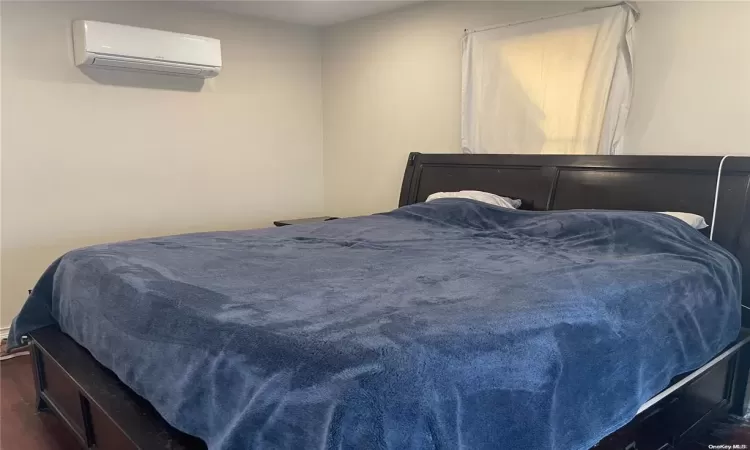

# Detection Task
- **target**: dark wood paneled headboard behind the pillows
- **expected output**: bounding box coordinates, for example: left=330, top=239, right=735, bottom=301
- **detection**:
left=399, top=153, right=750, bottom=327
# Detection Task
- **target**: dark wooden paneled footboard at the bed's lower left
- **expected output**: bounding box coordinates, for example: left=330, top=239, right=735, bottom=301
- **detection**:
left=31, top=327, right=206, bottom=450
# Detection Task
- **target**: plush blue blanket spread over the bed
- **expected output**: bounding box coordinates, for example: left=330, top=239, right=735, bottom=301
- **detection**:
left=11, top=199, right=740, bottom=450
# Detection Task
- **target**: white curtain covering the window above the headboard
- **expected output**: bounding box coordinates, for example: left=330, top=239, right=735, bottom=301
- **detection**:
left=461, top=3, right=637, bottom=154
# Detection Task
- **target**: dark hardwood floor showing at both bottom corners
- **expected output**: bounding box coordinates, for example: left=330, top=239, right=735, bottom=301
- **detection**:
left=0, top=356, right=750, bottom=450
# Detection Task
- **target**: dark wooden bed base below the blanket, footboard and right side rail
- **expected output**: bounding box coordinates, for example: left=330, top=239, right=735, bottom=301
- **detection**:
left=31, top=327, right=750, bottom=450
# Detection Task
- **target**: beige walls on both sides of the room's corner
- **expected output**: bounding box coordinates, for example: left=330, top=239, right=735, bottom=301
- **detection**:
left=0, top=1, right=750, bottom=326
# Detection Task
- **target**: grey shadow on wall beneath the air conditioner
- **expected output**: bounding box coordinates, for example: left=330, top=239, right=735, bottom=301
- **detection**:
left=80, top=67, right=204, bottom=92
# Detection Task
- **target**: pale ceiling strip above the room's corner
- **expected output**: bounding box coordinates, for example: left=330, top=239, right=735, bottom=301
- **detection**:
left=207, top=0, right=423, bottom=26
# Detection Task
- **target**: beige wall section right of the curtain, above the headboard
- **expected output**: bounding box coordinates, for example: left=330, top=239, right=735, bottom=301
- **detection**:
left=626, top=2, right=750, bottom=155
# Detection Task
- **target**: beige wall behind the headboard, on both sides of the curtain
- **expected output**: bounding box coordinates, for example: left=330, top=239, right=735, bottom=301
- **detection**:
left=323, top=2, right=750, bottom=215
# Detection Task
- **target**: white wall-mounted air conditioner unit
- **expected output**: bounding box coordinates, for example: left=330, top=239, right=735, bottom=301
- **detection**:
left=73, top=20, right=221, bottom=78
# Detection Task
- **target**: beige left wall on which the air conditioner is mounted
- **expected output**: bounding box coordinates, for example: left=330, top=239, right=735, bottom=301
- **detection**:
left=0, top=2, right=323, bottom=326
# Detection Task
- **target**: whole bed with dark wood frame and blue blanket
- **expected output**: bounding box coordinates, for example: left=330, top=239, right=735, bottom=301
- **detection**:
left=10, top=154, right=750, bottom=449
